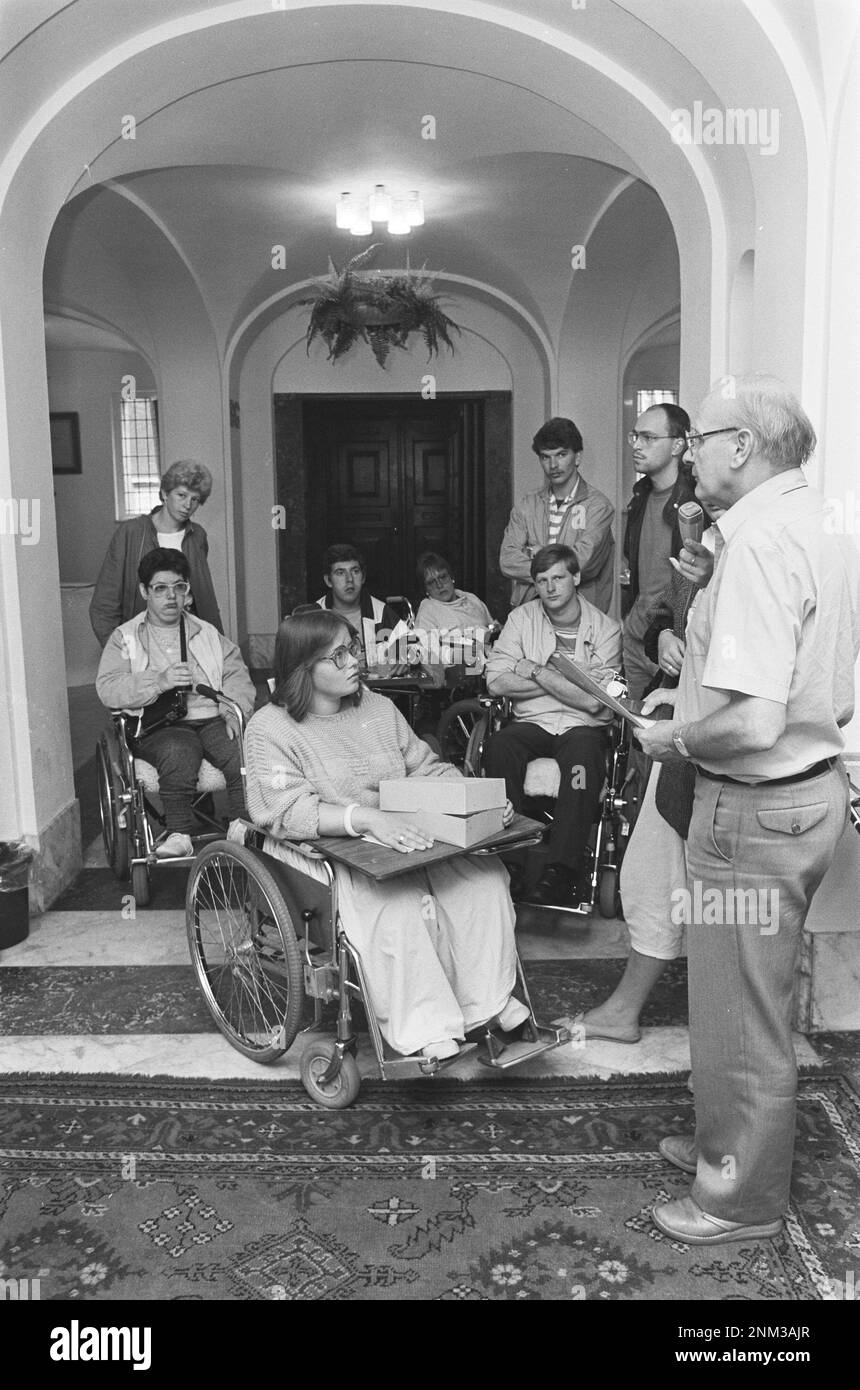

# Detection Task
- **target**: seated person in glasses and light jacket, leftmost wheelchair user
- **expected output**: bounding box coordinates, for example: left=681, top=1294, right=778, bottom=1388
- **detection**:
left=96, top=549, right=256, bottom=858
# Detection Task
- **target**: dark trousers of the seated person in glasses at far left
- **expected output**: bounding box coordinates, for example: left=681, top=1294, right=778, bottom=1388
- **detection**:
left=135, top=714, right=247, bottom=835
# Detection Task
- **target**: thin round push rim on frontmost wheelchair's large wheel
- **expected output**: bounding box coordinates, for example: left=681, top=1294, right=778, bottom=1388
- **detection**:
left=193, top=855, right=293, bottom=1054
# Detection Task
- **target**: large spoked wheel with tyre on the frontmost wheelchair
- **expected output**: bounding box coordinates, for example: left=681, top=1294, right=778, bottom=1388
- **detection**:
left=185, top=840, right=304, bottom=1062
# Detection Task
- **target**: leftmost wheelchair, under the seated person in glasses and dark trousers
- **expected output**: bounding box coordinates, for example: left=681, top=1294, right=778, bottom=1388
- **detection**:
left=96, top=702, right=238, bottom=908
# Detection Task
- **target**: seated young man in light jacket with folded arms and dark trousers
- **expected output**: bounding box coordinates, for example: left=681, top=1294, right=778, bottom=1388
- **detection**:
left=483, top=545, right=621, bottom=906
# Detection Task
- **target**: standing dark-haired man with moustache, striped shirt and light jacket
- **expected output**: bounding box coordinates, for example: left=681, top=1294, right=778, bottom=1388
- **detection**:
left=499, top=416, right=615, bottom=613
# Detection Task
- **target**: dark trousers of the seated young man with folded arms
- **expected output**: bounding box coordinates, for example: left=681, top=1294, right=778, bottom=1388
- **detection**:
left=483, top=720, right=606, bottom=869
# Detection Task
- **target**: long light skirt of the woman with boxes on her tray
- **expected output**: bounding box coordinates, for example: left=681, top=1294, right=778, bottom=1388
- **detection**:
left=265, top=837, right=517, bottom=1054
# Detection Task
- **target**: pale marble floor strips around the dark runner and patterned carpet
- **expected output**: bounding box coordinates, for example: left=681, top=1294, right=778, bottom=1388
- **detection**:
left=0, top=822, right=839, bottom=1084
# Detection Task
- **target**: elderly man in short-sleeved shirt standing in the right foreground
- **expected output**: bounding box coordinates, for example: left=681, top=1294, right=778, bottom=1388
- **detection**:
left=636, top=377, right=860, bottom=1245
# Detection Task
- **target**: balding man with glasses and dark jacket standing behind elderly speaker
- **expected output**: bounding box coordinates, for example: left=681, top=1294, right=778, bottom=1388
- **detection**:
left=621, top=403, right=695, bottom=699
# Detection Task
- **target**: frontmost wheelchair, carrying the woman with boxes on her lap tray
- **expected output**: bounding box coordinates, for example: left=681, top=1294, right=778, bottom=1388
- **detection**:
left=186, top=683, right=572, bottom=1109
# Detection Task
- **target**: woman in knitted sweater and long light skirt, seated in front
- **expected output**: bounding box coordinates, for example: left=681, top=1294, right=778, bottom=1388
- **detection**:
left=245, top=612, right=528, bottom=1059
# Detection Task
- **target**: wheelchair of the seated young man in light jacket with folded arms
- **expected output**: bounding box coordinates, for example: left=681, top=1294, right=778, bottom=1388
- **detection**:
left=438, top=695, right=638, bottom=917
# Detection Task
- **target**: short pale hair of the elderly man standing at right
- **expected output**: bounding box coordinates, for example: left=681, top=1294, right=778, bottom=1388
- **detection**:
left=706, top=373, right=817, bottom=468
